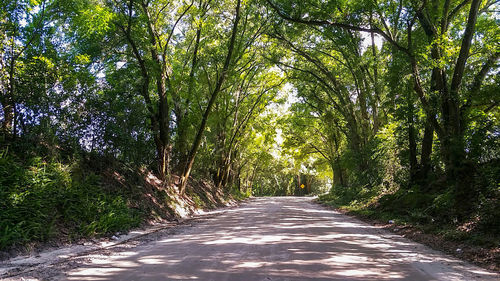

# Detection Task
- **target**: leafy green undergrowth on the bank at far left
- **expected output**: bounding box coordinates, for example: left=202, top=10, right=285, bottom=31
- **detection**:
left=0, top=151, right=143, bottom=250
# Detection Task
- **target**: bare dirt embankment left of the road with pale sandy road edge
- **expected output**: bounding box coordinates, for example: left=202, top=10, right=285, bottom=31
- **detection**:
left=0, top=168, right=242, bottom=280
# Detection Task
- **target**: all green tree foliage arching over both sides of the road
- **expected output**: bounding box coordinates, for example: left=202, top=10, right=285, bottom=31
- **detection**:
left=0, top=0, right=500, bottom=247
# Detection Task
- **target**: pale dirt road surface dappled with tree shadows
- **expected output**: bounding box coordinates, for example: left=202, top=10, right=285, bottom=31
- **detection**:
left=61, top=197, right=496, bottom=280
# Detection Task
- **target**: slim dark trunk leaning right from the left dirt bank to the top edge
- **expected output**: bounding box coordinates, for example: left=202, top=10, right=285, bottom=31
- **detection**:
left=180, top=0, right=241, bottom=194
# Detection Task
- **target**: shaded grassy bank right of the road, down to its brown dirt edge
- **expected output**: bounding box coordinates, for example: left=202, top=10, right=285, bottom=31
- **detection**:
left=318, top=186, right=500, bottom=271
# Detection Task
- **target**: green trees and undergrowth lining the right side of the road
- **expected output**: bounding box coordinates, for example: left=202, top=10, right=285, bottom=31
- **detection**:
left=267, top=0, right=500, bottom=245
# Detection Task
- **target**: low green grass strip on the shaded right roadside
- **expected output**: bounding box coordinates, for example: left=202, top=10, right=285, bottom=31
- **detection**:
left=318, top=190, right=500, bottom=248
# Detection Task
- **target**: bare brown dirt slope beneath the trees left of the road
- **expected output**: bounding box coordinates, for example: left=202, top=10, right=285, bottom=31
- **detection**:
left=0, top=159, right=242, bottom=262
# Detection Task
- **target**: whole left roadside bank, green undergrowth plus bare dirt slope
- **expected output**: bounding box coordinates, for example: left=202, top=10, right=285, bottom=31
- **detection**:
left=0, top=144, right=246, bottom=254
